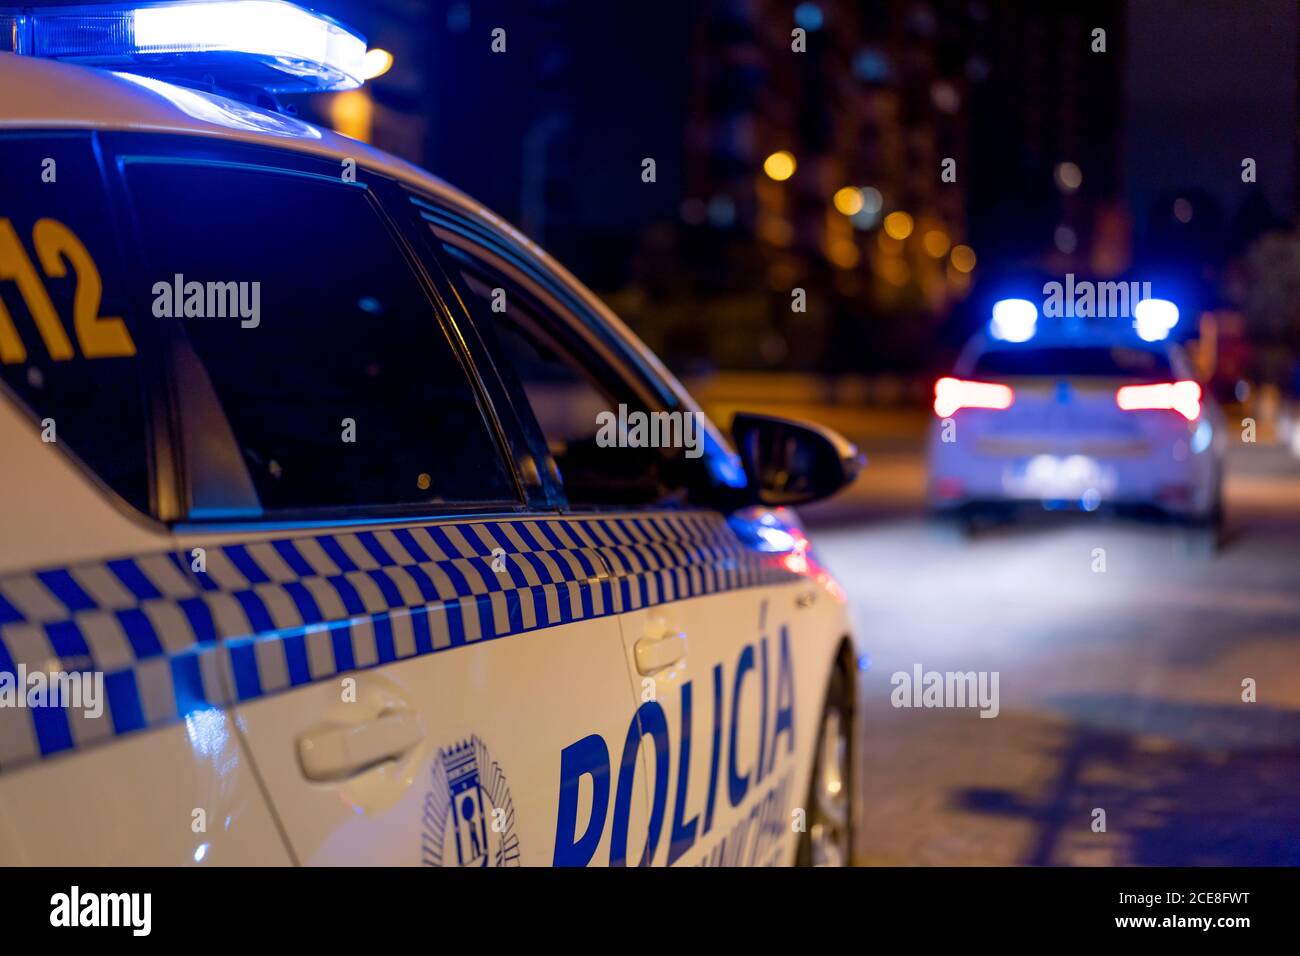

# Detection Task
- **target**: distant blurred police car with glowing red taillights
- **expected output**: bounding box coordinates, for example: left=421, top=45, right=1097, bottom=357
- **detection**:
left=928, top=298, right=1226, bottom=535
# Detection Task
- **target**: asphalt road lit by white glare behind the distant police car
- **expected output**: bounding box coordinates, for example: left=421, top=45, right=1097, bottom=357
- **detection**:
left=805, top=441, right=1300, bottom=865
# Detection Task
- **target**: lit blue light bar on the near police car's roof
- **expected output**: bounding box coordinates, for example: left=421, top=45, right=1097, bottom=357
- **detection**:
left=0, top=0, right=365, bottom=92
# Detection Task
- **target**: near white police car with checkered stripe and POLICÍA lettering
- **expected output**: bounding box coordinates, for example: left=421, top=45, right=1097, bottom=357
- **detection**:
left=0, top=1, right=861, bottom=866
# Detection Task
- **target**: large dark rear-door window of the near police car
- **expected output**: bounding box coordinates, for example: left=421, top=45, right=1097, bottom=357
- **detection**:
left=125, top=160, right=517, bottom=511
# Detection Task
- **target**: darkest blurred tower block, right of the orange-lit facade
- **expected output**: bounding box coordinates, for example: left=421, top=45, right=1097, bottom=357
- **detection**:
left=966, top=0, right=1132, bottom=278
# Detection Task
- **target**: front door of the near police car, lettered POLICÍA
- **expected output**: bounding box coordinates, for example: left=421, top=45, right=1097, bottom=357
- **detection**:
left=421, top=206, right=832, bottom=865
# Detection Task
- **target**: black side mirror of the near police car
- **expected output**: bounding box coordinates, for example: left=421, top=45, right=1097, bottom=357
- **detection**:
left=732, top=412, right=866, bottom=506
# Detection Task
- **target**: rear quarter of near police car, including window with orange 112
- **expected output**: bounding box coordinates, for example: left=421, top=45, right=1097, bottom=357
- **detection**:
left=0, top=130, right=287, bottom=866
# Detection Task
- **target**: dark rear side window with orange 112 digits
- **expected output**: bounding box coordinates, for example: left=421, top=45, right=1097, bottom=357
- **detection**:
left=0, top=133, right=151, bottom=512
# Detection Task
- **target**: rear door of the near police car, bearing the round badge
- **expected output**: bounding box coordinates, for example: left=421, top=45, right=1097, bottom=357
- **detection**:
left=117, top=138, right=644, bottom=866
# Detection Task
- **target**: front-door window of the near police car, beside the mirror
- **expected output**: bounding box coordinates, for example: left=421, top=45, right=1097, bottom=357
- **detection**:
left=442, top=243, right=702, bottom=506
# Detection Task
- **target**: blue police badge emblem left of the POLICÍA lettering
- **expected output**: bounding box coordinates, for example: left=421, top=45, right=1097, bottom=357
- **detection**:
left=420, top=736, right=519, bottom=866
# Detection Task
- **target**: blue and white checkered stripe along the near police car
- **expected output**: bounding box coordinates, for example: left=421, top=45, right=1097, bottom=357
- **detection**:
left=0, top=511, right=792, bottom=771
